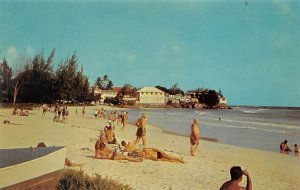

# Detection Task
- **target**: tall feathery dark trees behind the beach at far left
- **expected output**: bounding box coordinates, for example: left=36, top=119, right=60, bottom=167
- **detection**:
left=0, top=49, right=113, bottom=103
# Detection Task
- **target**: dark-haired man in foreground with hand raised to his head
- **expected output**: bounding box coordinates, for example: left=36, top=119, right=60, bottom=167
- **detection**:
left=220, top=166, right=252, bottom=190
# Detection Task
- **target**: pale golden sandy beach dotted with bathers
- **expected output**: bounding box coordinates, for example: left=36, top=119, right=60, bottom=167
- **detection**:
left=0, top=106, right=300, bottom=190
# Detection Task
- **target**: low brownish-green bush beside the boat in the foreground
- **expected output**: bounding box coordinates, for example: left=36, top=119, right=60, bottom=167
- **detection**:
left=57, top=169, right=132, bottom=190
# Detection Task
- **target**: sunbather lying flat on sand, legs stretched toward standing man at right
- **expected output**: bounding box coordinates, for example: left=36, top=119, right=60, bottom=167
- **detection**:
left=138, top=148, right=184, bottom=163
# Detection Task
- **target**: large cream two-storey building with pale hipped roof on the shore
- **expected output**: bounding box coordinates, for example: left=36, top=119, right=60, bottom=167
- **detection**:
left=137, top=87, right=165, bottom=105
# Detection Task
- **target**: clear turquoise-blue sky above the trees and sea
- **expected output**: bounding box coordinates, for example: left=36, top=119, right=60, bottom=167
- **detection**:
left=0, top=0, right=300, bottom=106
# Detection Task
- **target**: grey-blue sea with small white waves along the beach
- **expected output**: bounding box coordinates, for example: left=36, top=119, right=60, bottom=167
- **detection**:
left=123, top=107, right=300, bottom=152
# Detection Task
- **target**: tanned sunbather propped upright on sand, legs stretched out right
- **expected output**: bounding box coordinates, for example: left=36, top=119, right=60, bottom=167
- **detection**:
left=95, top=139, right=143, bottom=162
